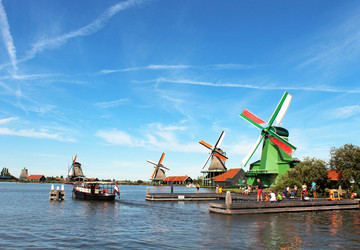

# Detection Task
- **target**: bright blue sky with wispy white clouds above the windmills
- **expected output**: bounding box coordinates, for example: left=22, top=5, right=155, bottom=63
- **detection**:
left=0, top=0, right=360, bottom=180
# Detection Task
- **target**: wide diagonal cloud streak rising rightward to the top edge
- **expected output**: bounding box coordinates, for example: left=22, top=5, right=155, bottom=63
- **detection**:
left=19, top=0, right=144, bottom=61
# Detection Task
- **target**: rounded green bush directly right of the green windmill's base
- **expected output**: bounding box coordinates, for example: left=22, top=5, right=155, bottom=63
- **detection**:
left=274, top=157, right=329, bottom=193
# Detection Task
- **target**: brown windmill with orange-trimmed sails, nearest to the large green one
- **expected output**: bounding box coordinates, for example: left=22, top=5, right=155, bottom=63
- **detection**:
left=199, top=131, right=228, bottom=186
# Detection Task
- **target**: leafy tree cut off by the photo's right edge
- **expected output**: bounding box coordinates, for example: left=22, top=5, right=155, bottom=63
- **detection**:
left=329, top=144, right=360, bottom=192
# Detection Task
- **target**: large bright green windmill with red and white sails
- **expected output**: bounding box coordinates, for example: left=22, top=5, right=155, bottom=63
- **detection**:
left=240, top=92, right=299, bottom=187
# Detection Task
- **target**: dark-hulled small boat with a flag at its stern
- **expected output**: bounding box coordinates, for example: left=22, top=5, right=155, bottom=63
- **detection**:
left=73, top=181, right=120, bottom=201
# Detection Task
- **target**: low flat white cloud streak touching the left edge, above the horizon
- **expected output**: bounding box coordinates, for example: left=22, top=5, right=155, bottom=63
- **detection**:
left=0, top=128, right=75, bottom=142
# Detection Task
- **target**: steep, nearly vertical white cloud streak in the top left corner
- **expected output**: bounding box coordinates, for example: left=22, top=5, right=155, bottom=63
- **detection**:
left=0, top=0, right=17, bottom=72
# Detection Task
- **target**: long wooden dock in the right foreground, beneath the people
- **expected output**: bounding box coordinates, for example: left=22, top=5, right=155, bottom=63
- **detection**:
left=209, top=199, right=359, bottom=215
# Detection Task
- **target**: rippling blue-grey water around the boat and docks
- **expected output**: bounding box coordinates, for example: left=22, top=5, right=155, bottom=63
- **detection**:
left=0, top=183, right=360, bottom=249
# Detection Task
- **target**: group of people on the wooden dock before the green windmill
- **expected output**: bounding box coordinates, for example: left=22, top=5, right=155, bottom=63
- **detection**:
left=255, top=179, right=317, bottom=201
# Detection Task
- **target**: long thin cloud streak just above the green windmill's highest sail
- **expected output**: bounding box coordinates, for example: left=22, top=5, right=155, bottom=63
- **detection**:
left=143, top=77, right=360, bottom=94
